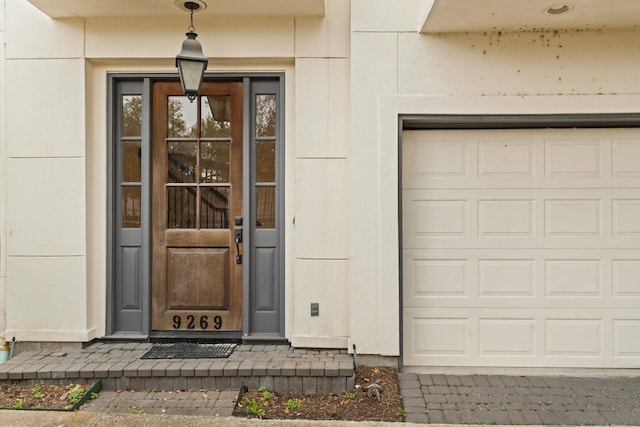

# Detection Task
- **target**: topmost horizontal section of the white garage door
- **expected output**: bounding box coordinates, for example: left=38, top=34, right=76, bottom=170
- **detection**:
left=402, top=129, right=640, bottom=189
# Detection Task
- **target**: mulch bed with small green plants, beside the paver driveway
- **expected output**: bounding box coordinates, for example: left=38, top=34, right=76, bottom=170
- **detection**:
left=236, top=367, right=404, bottom=422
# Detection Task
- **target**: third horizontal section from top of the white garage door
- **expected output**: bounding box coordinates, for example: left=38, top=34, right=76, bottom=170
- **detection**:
left=403, top=249, right=640, bottom=308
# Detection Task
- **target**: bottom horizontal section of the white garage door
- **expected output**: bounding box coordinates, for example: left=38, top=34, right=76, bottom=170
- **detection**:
left=403, top=308, right=640, bottom=367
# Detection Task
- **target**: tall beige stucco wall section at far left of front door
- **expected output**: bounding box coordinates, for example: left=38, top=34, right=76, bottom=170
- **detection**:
left=3, top=0, right=88, bottom=341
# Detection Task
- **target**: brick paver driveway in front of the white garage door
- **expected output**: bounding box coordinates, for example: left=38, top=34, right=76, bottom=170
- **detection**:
left=399, top=373, right=640, bottom=426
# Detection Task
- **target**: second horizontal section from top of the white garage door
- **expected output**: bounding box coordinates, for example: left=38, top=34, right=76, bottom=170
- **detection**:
left=402, top=190, right=640, bottom=248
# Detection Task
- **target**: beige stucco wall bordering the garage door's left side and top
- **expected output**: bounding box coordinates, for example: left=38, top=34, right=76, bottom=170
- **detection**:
left=349, top=0, right=640, bottom=355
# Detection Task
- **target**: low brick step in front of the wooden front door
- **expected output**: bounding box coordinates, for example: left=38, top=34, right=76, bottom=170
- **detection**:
left=0, top=343, right=355, bottom=394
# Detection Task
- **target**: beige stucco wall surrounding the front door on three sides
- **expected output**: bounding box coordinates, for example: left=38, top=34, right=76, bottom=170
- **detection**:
left=0, top=0, right=350, bottom=347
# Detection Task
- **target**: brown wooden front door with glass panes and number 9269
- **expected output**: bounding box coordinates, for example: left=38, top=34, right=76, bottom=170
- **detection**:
left=151, top=82, right=243, bottom=332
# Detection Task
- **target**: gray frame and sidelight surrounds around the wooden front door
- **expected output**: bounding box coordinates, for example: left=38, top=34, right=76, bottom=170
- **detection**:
left=105, top=73, right=285, bottom=341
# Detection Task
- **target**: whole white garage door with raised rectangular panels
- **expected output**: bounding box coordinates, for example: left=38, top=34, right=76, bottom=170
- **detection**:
left=402, top=129, right=640, bottom=367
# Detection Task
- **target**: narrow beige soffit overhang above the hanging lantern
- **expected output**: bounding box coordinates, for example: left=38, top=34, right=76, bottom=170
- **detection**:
left=28, top=0, right=326, bottom=19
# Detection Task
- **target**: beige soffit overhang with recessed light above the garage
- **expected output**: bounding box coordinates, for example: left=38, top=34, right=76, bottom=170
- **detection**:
left=419, top=0, right=640, bottom=34
